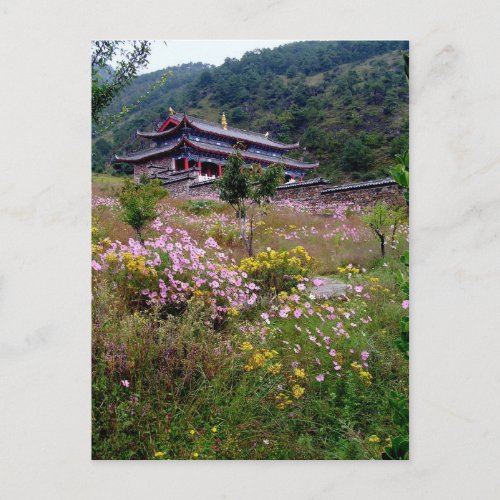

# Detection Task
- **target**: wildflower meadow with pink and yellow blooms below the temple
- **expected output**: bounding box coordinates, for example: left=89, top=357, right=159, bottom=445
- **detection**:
left=92, top=178, right=408, bottom=460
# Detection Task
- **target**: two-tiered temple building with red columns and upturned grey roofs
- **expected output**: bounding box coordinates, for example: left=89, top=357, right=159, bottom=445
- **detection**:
left=115, top=108, right=319, bottom=186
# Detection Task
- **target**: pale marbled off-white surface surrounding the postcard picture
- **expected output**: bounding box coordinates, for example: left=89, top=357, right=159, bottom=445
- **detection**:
left=0, top=0, right=500, bottom=500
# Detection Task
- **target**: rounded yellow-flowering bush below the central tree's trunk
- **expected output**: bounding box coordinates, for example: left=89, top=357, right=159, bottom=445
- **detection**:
left=240, top=246, right=316, bottom=292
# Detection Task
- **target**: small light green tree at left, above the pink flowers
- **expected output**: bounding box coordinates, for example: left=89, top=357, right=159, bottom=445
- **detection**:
left=118, top=176, right=168, bottom=245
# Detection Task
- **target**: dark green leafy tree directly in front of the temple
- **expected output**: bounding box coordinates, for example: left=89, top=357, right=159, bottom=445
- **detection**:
left=215, top=148, right=284, bottom=257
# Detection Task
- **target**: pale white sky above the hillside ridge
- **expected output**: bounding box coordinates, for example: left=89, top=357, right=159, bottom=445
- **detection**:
left=137, top=40, right=295, bottom=74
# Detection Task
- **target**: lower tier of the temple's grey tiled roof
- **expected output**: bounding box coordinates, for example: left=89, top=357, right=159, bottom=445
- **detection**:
left=115, top=137, right=319, bottom=170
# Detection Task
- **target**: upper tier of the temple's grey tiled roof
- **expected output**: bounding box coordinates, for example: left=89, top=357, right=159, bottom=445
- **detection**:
left=137, top=113, right=299, bottom=149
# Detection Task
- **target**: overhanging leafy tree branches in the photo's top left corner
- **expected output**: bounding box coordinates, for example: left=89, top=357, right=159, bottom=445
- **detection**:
left=91, top=40, right=151, bottom=123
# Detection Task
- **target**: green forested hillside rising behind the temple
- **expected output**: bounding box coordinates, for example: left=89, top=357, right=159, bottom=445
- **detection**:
left=92, top=41, right=408, bottom=181
